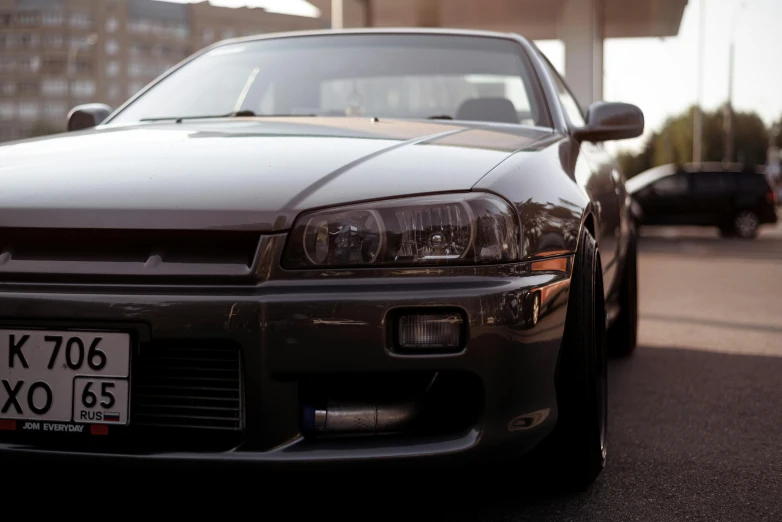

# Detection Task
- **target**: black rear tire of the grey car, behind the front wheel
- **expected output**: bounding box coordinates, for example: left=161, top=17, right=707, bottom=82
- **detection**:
left=608, top=237, right=638, bottom=357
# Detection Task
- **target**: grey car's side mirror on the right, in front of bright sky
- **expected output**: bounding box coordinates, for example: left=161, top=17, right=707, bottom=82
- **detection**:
left=573, top=102, right=644, bottom=142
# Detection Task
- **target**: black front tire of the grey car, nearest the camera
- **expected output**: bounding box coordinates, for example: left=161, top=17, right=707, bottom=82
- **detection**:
left=540, top=231, right=608, bottom=491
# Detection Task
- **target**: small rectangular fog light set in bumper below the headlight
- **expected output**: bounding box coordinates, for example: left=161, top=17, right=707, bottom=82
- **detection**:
left=398, top=313, right=463, bottom=353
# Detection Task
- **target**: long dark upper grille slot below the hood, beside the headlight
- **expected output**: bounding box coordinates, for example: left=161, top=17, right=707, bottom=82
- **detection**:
left=0, top=227, right=262, bottom=283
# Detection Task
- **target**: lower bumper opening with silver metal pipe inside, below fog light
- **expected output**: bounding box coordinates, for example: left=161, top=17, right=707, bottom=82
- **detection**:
left=299, top=372, right=483, bottom=440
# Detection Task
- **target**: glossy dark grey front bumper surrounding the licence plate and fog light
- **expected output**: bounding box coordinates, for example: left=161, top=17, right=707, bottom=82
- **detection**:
left=0, top=242, right=572, bottom=469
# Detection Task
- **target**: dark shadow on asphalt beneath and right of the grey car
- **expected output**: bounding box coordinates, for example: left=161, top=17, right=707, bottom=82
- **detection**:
left=47, top=347, right=782, bottom=522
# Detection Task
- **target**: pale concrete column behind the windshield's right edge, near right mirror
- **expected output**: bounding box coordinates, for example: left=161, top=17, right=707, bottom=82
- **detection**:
left=558, top=0, right=604, bottom=106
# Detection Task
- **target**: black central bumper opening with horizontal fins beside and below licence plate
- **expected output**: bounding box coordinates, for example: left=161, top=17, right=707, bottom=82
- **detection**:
left=0, top=339, right=244, bottom=455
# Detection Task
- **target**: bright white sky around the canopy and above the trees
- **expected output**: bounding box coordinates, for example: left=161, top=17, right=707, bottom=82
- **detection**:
left=156, top=0, right=782, bottom=154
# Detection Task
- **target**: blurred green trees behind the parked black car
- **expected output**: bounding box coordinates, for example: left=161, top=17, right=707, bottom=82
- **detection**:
left=619, top=107, right=782, bottom=177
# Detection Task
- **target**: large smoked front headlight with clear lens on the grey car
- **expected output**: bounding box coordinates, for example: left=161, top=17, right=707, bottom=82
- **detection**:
left=283, top=192, right=521, bottom=268
